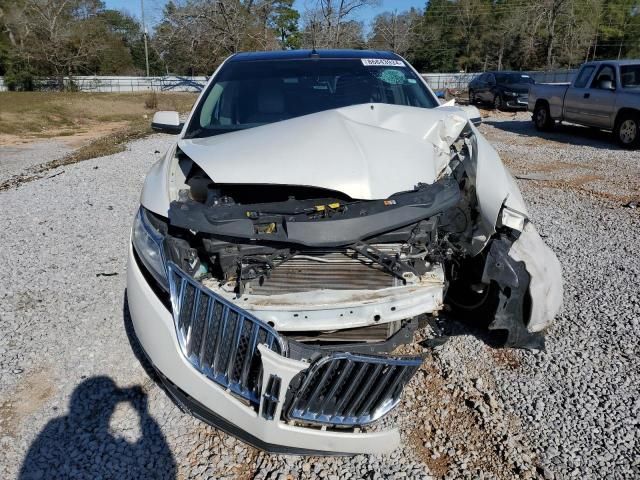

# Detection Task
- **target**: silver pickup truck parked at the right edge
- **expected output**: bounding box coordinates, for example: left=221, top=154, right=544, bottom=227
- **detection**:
left=528, top=60, right=640, bottom=149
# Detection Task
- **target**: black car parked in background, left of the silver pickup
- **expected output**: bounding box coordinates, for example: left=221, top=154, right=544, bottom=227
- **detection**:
left=469, top=72, right=535, bottom=110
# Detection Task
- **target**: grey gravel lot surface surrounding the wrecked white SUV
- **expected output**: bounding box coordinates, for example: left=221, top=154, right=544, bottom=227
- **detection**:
left=0, top=114, right=640, bottom=479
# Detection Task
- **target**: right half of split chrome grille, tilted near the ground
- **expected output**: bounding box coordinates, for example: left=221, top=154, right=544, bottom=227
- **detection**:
left=287, top=353, right=422, bottom=426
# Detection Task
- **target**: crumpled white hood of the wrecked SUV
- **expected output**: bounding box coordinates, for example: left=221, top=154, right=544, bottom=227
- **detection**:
left=178, top=104, right=468, bottom=200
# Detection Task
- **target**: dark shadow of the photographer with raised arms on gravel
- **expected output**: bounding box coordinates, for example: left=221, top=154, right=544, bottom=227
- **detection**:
left=19, top=376, right=176, bottom=480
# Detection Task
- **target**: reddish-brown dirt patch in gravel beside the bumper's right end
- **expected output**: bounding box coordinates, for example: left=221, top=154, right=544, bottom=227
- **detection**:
left=402, top=358, right=535, bottom=478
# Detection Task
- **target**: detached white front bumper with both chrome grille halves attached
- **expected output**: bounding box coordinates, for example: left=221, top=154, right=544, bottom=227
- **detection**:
left=128, top=248, right=422, bottom=455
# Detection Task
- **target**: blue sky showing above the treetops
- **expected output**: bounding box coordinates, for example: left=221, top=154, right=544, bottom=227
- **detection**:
left=104, top=0, right=426, bottom=25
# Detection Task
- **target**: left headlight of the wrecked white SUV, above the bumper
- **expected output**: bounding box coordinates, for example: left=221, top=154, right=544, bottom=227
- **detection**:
left=131, top=207, right=169, bottom=291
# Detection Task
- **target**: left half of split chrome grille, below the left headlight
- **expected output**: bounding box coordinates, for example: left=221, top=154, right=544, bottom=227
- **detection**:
left=167, top=262, right=285, bottom=405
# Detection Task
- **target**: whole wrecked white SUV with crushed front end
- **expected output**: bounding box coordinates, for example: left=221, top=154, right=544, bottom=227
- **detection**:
left=127, top=50, right=562, bottom=454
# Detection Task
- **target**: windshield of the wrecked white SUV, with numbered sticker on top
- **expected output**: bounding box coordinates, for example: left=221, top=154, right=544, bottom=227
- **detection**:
left=185, top=58, right=439, bottom=138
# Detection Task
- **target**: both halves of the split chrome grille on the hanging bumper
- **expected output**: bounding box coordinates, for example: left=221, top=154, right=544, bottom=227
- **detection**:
left=167, top=262, right=422, bottom=427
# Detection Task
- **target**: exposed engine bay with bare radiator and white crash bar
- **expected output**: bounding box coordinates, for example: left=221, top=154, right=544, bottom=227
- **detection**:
left=149, top=119, right=544, bottom=352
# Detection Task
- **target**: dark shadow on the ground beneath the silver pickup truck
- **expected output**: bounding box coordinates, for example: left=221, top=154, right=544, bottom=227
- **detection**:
left=482, top=119, right=620, bottom=150
